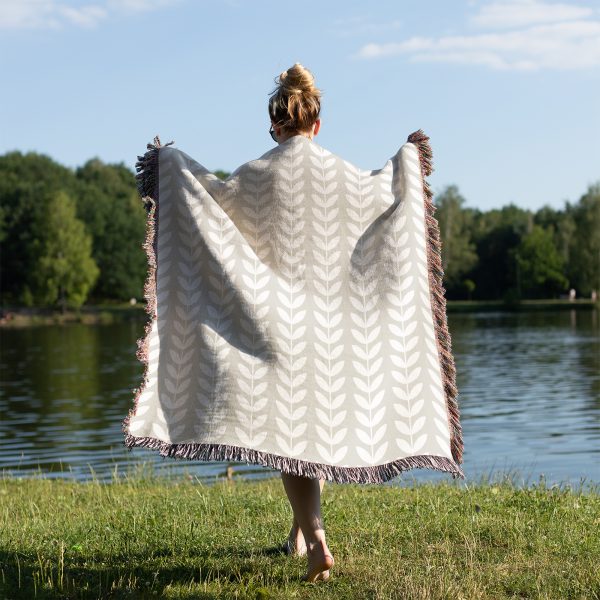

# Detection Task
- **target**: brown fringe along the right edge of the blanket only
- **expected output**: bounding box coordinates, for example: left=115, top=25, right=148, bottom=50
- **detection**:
left=407, top=129, right=464, bottom=468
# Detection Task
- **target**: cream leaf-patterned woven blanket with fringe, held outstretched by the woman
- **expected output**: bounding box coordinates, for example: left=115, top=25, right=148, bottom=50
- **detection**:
left=123, top=130, right=464, bottom=483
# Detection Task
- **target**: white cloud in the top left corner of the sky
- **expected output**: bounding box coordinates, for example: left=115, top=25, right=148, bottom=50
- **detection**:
left=0, top=0, right=178, bottom=29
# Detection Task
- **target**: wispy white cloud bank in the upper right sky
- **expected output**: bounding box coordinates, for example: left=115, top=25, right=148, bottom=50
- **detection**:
left=356, top=0, right=600, bottom=71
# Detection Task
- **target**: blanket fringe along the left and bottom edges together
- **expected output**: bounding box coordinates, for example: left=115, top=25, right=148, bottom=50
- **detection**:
left=123, top=136, right=465, bottom=483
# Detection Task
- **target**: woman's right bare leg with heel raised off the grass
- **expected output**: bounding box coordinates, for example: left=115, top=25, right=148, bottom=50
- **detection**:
left=281, top=472, right=333, bottom=581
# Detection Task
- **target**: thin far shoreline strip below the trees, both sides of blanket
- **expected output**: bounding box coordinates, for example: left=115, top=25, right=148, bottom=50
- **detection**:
left=0, top=298, right=600, bottom=327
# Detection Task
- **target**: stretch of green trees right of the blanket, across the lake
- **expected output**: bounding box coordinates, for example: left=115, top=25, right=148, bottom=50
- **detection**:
left=434, top=181, right=600, bottom=302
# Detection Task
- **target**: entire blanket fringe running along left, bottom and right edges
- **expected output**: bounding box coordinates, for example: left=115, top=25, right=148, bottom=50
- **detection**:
left=122, top=130, right=465, bottom=484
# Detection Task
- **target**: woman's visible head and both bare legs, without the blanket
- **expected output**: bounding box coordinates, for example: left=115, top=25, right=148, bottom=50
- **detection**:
left=269, top=63, right=334, bottom=581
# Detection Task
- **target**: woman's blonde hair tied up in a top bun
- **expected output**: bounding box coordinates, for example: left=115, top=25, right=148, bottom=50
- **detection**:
left=269, top=63, right=321, bottom=131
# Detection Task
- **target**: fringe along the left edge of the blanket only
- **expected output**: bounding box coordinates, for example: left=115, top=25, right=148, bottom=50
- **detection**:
left=122, top=136, right=174, bottom=438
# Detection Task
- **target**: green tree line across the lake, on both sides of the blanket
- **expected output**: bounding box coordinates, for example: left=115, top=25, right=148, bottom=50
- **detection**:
left=0, top=151, right=600, bottom=308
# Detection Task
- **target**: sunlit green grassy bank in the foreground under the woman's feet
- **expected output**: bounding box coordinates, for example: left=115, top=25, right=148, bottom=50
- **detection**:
left=0, top=476, right=600, bottom=600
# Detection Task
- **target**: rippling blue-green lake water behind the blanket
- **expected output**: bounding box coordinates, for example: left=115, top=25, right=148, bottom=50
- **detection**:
left=0, top=309, right=600, bottom=488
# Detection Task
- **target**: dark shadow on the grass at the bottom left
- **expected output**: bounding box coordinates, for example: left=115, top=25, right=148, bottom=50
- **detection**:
left=0, top=546, right=286, bottom=600
